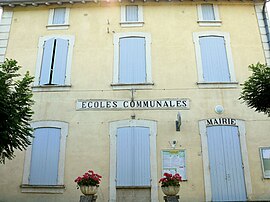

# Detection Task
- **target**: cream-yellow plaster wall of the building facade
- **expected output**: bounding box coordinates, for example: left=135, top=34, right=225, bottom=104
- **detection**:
left=0, top=2, right=270, bottom=202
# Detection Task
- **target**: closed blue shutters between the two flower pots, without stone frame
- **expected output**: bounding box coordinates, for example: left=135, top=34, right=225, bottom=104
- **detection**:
left=116, top=127, right=150, bottom=186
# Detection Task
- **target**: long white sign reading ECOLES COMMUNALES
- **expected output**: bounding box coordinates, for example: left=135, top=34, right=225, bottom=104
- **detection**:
left=76, top=99, right=189, bottom=110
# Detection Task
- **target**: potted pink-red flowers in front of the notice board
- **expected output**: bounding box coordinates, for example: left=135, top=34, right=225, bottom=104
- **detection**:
left=159, top=173, right=182, bottom=196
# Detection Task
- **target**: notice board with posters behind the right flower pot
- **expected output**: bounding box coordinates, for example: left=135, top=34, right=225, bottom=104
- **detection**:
left=161, top=150, right=187, bottom=180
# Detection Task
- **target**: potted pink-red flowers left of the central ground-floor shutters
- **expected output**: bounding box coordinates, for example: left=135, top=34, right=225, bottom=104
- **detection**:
left=75, top=170, right=102, bottom=195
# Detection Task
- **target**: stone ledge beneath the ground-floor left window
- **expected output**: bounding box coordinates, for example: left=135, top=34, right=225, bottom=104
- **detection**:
left=20, top=184, right=66, bottom=194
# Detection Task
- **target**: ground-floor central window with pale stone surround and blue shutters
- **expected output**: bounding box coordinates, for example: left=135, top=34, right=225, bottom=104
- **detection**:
left=109, top=119, right=158, bottom=201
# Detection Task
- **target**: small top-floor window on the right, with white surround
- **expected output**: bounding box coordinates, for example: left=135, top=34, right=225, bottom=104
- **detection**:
left=197, top=4, right=221, bottom=26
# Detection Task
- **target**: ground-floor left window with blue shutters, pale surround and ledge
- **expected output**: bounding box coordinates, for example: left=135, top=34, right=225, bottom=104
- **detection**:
left=21, top=121, right=68, bottom=193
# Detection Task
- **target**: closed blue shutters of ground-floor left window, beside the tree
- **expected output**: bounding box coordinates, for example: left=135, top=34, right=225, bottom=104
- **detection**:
left=29, top=128, right=60, bottom=185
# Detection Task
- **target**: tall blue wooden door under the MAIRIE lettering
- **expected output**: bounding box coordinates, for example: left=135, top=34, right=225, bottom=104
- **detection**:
left=207, top=126, right=246, bottom=201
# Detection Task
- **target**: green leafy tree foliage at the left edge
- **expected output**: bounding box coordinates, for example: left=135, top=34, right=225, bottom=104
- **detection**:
left=0, top=59, right=34, bottom=163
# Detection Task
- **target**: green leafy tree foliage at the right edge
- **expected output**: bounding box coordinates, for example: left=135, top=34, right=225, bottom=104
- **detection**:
left=239, top=63, right=270, bottom=116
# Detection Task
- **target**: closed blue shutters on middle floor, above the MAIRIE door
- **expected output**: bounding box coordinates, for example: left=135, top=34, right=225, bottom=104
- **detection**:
left=199, top=36, right=230, bottom=82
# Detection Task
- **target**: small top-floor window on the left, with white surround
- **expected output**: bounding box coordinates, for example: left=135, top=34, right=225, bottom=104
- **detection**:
left=47, top=8, right=70, bottom=29
